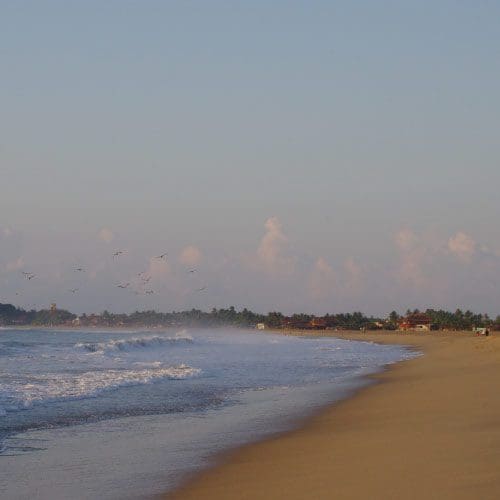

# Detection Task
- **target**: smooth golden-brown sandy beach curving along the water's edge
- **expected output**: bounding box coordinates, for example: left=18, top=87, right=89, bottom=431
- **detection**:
left=166, top=332, right=500, bottom=500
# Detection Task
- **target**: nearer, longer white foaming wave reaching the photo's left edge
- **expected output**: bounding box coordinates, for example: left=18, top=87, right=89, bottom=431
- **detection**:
left=0, top=364, right=201, bottom=416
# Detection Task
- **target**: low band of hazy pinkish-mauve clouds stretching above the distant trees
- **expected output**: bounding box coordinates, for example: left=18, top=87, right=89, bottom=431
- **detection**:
left=0, top=220, right=500, bottom=314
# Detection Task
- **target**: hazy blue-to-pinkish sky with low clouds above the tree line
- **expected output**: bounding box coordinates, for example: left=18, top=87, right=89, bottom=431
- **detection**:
left=0, top=0, right=500, bottom=316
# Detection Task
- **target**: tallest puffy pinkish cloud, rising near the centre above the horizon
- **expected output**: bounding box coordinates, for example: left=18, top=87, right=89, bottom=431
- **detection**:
left=257, top=217, right=295, bottom=274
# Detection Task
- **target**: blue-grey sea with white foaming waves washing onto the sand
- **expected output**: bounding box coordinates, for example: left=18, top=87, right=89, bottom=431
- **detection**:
left=0, top=329, right=414, bottom=500
